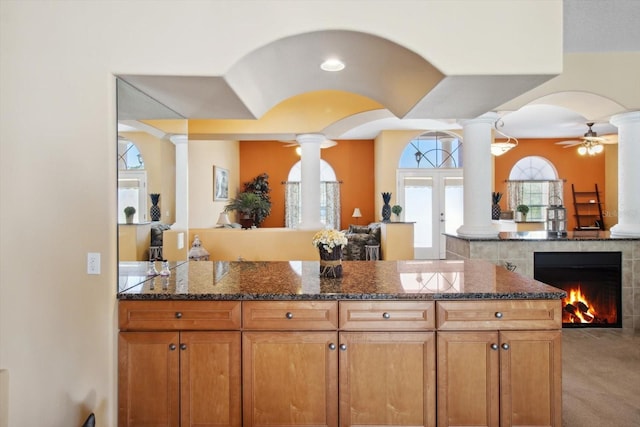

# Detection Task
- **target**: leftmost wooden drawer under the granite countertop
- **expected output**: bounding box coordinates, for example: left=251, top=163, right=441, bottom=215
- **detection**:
left=118, top=301, right=241, bottom=331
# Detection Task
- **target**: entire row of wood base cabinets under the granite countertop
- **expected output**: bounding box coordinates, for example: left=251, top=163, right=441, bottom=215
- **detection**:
left=118, top=300, right=562, bottom=427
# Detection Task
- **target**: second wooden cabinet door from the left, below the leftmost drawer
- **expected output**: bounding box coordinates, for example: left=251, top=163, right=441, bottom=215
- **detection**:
left=180, top=332, right=242, bottom=427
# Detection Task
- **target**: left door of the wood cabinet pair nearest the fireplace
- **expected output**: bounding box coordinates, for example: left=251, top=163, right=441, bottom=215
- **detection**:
left=437, top=332, right=500, bottom=427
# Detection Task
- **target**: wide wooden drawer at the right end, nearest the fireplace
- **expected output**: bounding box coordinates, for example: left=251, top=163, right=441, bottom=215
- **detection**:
left=436, top=300, right=562, bottom=330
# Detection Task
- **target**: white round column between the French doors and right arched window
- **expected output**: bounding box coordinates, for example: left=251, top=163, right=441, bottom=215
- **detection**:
left=456, top=113, right=498, bottom=238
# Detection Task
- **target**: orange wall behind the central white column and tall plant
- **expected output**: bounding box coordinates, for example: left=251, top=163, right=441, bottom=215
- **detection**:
left=238, top=140, right=379, bottom=229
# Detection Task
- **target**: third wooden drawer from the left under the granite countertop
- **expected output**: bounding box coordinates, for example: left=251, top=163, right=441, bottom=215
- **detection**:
left=340, top=301, right=436, bottom=331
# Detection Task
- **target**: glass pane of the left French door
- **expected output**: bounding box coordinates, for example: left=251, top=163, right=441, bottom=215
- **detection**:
left=404, top=177, right=433, bottom=248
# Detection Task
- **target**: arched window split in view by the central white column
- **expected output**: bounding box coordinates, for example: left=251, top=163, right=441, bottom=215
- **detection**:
left=285, top=159, right=340, bottom=229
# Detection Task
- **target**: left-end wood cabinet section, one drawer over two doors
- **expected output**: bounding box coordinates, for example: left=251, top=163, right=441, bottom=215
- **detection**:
left=118, top=301, right=242, bottom=427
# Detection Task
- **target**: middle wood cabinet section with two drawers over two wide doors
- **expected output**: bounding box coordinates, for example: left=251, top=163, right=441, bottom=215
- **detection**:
left=243, top=301, right=435, bottom=427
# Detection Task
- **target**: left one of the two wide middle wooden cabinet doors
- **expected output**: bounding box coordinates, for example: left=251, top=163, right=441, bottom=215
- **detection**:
left=242, top=332, right=338, bottom=427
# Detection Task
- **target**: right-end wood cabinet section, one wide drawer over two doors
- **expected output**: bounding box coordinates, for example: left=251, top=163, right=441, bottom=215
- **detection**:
left=437, top=301, right=562, bottom=427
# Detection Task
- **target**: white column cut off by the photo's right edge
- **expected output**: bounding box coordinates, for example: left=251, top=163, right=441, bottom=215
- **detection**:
left=610, top=111, right=640, bottom=237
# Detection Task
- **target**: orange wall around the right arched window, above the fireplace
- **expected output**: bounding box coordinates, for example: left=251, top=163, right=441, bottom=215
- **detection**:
left=494, top=138, right=608, bottom=230
